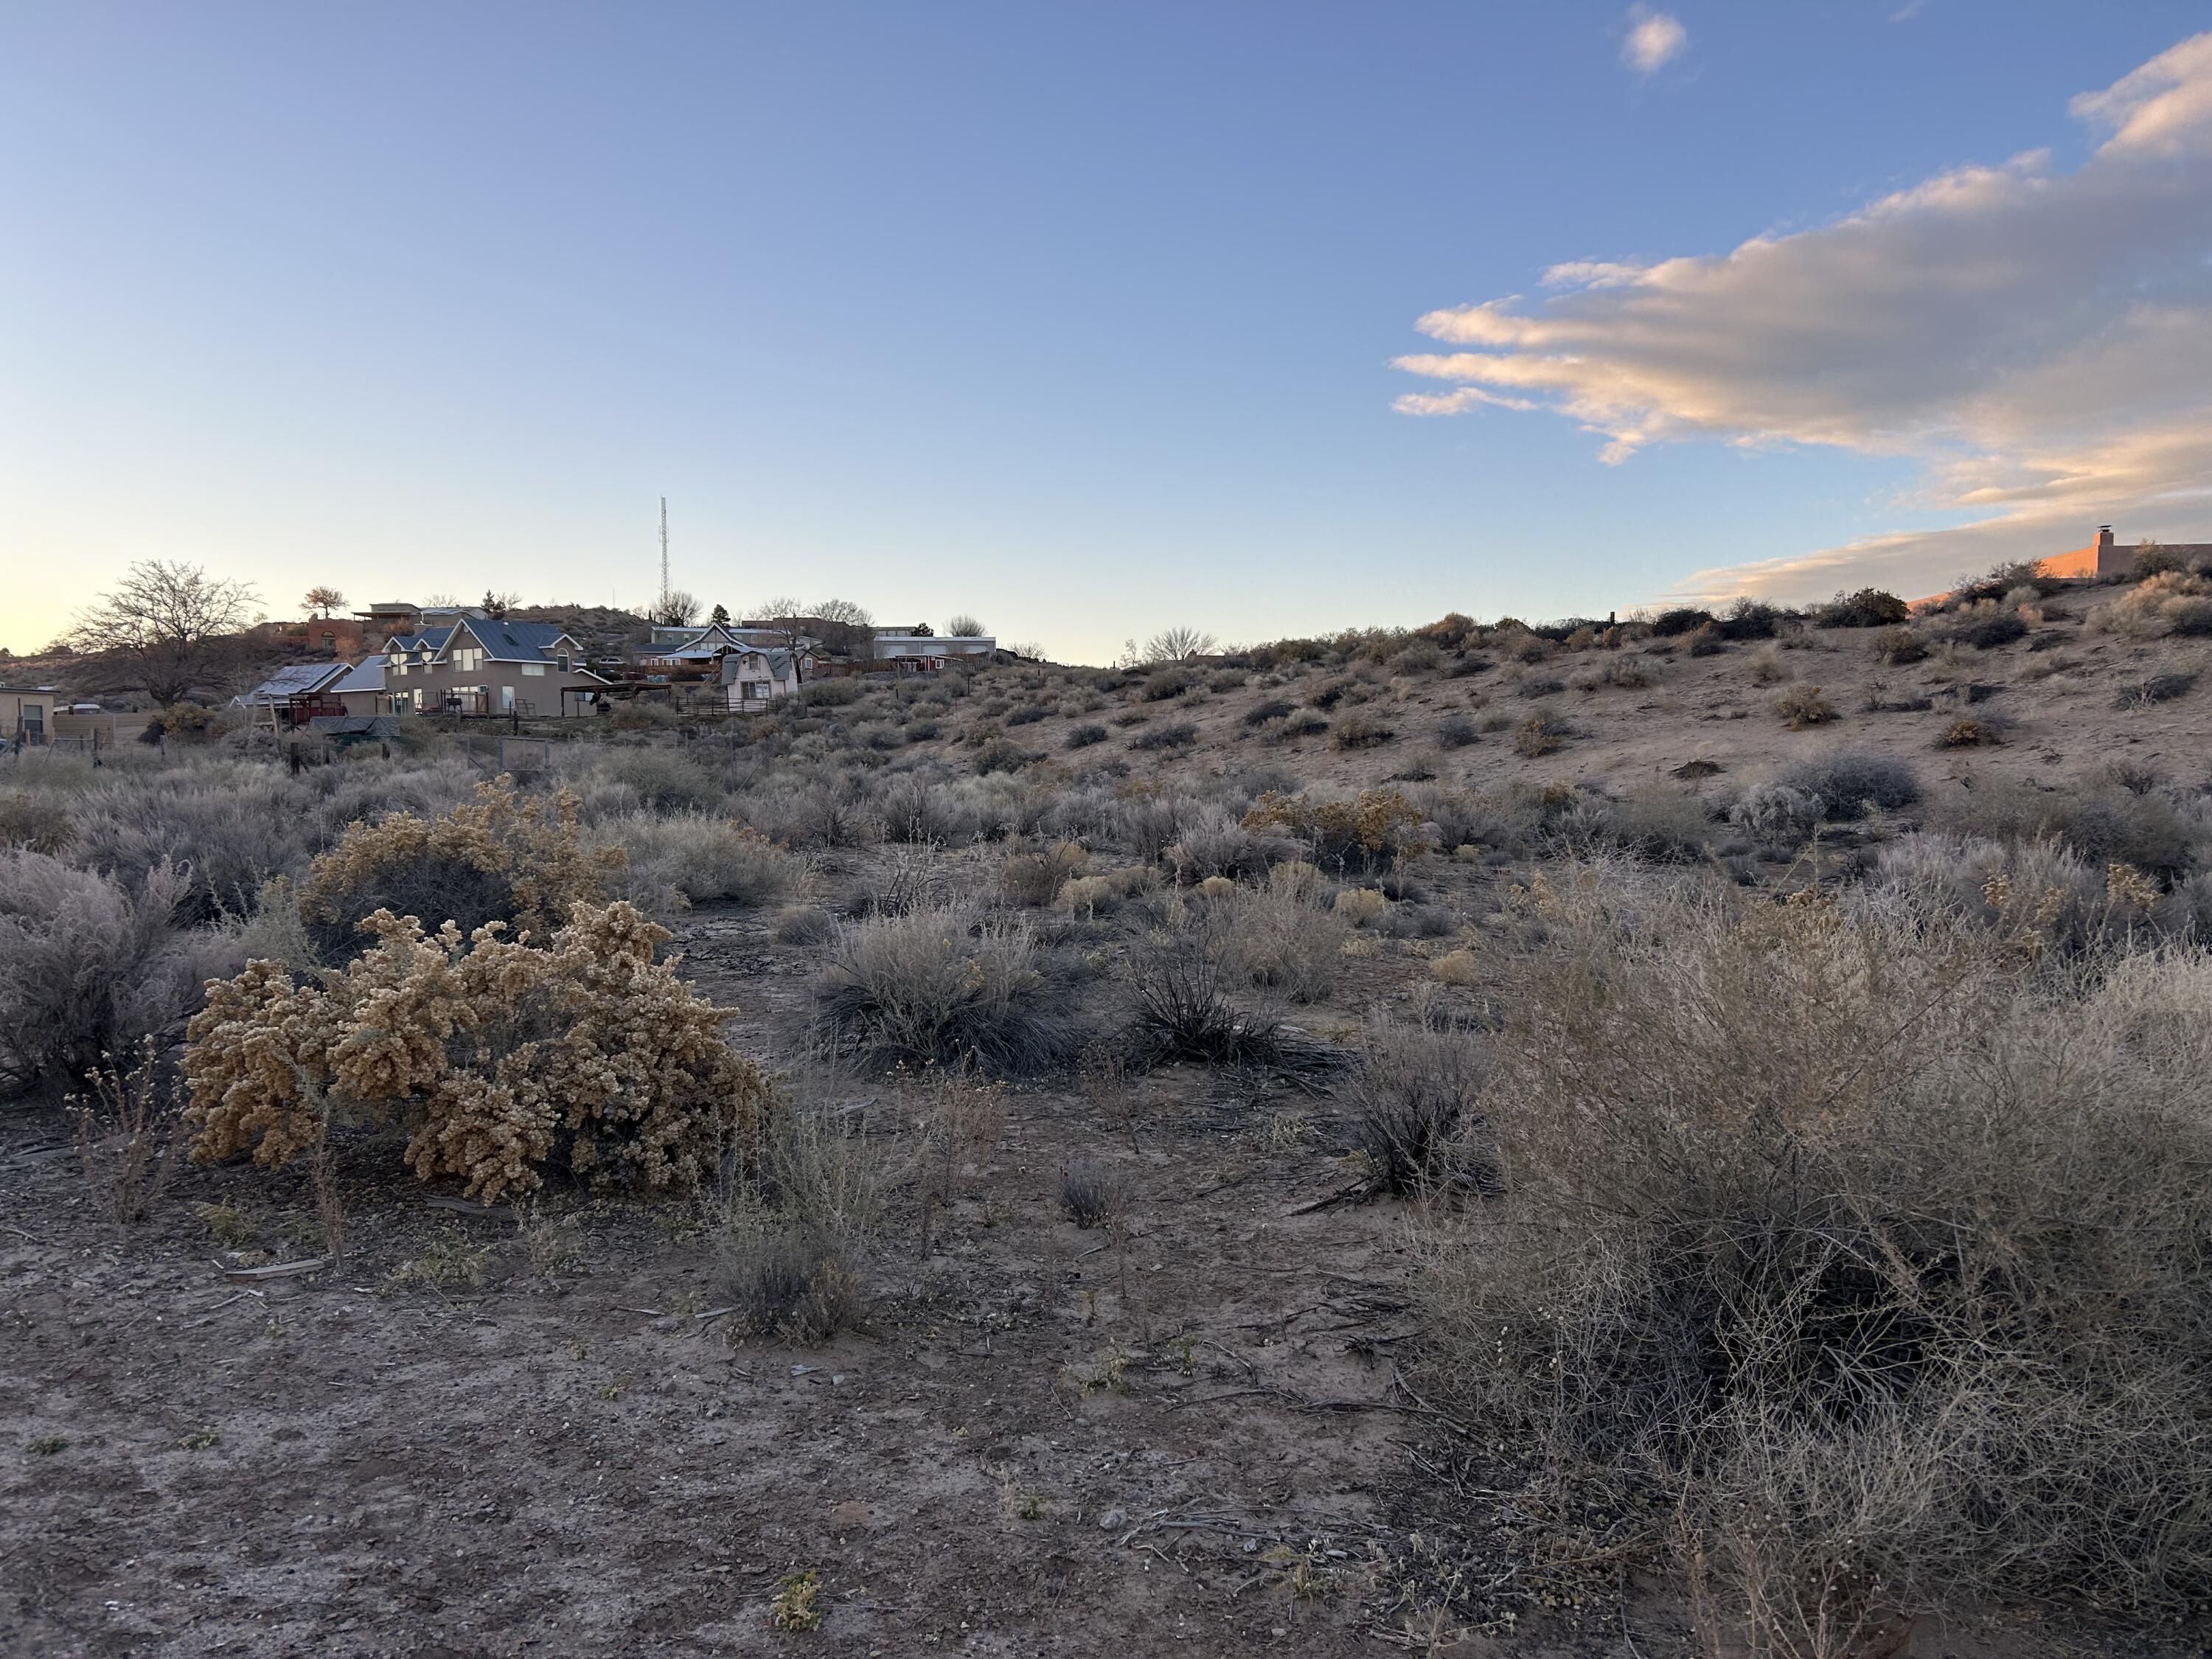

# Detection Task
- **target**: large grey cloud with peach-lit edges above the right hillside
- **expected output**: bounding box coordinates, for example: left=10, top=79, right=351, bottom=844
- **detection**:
left=1398, top=33, right=2212, bottom=593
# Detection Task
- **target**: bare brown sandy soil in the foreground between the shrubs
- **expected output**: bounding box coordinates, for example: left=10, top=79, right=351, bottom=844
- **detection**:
left=0, top=898, right=1540, bottom=1655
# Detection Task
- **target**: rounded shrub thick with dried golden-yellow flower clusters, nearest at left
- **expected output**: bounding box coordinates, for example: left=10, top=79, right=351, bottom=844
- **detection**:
left=184, top=902, right=768, bottom=1203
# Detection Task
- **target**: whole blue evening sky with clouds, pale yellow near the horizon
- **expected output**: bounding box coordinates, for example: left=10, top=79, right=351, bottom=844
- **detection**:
left=0, top=0, right=2212, bottom=661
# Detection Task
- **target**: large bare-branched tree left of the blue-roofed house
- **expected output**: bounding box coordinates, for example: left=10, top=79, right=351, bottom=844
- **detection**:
left=69, top=560, right=259, bottom=706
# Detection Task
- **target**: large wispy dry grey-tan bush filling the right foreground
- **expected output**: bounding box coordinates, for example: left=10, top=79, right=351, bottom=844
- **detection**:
left=1425, top=876, right=2212, bottom=1655
